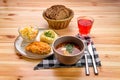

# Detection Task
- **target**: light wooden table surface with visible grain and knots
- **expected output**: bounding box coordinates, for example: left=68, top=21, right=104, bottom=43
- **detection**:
left=0, top=0, right=120, bottom=80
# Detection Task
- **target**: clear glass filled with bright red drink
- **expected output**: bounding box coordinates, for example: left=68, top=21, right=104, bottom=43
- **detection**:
left=77, top=16, right=94, bottom=36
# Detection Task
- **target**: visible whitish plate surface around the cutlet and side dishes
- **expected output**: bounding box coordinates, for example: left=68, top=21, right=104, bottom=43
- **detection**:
left=14, top=30, right=53, bottom=59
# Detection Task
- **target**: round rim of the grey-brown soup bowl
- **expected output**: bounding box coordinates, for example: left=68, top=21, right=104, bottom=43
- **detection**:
left=52, top=36, right=85, bottom=57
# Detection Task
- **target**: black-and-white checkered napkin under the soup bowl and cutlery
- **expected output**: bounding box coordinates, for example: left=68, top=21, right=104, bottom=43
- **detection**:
left=34, top=34, right=101, bottom=70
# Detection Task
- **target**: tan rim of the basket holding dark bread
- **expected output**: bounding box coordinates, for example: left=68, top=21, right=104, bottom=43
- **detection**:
left=43, top=8, right=74, bottom=22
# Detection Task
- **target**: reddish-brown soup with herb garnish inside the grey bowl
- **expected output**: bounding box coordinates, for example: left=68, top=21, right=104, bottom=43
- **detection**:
left=56, top=42, right=80, bottom=55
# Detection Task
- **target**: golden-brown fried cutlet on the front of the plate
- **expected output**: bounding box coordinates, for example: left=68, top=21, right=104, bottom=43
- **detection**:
left=25, top=41, right=51, bottom=55
